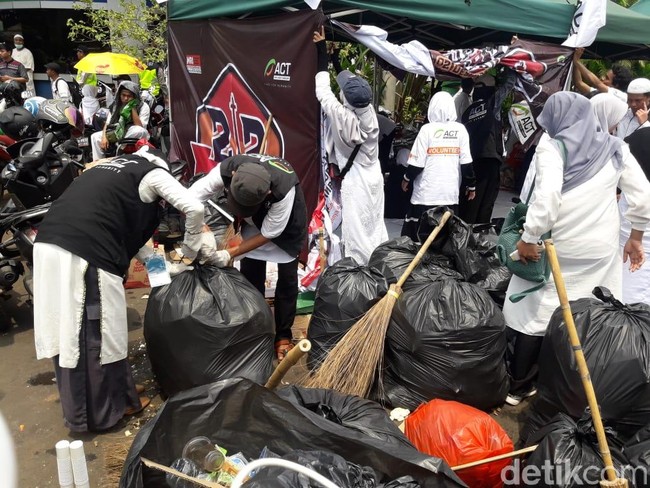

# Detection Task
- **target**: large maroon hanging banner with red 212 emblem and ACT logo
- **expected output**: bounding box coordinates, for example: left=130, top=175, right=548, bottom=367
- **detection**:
left=169, top=11, right=320, bottom=215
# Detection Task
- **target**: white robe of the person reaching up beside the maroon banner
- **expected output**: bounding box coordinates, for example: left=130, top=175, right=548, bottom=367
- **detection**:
left=316, top=71, right=388, bottom=264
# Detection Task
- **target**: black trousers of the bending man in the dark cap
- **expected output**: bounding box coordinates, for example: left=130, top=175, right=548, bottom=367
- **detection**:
left=240, top=258, right=298, bottom=342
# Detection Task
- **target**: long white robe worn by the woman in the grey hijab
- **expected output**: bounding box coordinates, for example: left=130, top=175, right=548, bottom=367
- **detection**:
left=503, top=137, right=650, bottom=336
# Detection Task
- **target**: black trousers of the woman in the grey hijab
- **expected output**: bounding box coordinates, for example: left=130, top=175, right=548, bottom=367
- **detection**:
left=506, top=327, right=544, bottom=395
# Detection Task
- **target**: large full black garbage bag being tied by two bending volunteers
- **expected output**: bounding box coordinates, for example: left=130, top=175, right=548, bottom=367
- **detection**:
left=144, top=266, right=275, bottom=395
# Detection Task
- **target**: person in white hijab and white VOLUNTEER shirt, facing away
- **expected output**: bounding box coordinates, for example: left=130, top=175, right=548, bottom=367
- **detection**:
left=402, top=92, right=476, bottom=241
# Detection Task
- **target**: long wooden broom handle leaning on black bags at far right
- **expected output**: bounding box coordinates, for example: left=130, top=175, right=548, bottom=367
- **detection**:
left=544, top=239, right=627, bottom=488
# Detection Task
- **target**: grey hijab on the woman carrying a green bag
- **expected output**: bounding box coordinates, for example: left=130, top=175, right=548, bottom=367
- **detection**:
left=537, top=91, right=622, bottom=192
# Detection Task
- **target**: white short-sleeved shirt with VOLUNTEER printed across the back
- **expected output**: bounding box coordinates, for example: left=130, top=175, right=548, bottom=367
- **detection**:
left=409, top=122, right=472, bottom=205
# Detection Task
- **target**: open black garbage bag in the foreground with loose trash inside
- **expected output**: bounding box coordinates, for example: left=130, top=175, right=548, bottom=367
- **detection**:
left=120, top=378, right=465, bottom=488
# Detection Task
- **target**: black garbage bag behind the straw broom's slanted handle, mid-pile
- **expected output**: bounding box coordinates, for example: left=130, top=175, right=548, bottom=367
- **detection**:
left=368, top=236, right=462, bottom=290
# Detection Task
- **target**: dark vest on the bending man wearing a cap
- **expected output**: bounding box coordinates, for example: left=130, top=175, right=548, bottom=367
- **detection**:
left=220, top=154, right=307, bottom=256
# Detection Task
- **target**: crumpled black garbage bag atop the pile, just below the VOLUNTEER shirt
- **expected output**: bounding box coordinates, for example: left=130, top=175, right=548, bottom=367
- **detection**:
left=418, top=207, right=512, bottom=296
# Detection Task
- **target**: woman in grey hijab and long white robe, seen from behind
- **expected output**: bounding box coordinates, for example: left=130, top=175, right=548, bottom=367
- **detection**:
left=503, top=92, right=650, bottom=405
